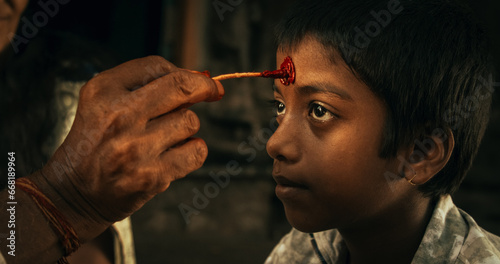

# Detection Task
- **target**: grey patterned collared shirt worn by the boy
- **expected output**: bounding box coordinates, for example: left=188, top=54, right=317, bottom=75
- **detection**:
left=265, top=196, right=500, bottom=264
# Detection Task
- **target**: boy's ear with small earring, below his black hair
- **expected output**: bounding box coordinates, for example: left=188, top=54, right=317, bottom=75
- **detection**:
left=404, top=129, right=455, bottom=185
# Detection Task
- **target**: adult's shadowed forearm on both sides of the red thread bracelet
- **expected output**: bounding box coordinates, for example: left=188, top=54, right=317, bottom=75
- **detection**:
left=0, top=172, right=112, bottom=263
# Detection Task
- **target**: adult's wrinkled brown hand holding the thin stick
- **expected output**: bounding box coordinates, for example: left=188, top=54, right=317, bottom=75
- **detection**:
left=41, top=56, right=224, bottom=239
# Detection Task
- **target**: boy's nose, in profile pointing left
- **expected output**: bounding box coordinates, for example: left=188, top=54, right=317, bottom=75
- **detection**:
left=266, top=116, right=301, bottom=163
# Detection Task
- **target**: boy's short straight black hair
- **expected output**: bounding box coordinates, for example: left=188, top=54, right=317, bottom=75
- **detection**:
left=276, top=0, right=493, bottom=197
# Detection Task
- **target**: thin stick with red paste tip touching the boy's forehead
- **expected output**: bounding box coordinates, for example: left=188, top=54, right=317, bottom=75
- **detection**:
left=191, top=56, right=295, bottom=85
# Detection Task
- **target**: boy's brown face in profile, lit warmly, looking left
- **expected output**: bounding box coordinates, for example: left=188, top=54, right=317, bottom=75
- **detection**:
left=267, top=37, right=409, bottom=232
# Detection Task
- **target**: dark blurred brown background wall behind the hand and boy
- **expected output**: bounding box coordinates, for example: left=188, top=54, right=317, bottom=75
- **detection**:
left=20, top=0, right=500, bottom=263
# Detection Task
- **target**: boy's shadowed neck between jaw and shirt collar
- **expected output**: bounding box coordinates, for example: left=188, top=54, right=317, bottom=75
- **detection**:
left=339, top=197, right=436, bottom=264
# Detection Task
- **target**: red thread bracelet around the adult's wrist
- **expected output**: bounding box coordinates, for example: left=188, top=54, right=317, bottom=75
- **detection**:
left=16, top=177, right=80, bottom=264
